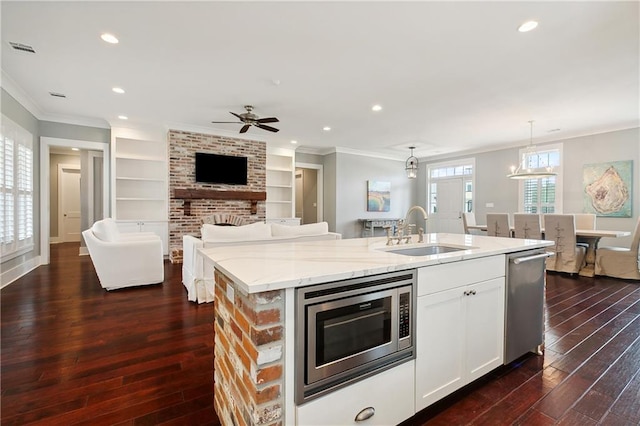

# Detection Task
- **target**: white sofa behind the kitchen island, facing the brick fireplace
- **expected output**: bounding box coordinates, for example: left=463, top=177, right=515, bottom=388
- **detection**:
left=182, top=222, right=342, bottom=303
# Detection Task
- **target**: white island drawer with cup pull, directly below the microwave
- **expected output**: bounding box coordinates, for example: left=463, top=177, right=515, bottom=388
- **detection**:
left=296, top=361, right=415, bottom=426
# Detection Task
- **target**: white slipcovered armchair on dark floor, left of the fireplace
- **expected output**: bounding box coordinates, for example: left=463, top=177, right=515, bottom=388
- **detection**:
left=82, top=218, right=164, bottom=290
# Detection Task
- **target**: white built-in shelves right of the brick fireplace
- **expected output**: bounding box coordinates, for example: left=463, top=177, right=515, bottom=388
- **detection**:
left=266, top=148, right=295, bottom=219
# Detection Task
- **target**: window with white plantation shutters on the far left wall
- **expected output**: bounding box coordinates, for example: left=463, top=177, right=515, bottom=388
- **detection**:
left=0, top=115, right=33, bottom=260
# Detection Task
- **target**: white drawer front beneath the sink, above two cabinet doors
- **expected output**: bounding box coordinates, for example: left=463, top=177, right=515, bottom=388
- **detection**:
left=417, top=254, right=505, bottom=296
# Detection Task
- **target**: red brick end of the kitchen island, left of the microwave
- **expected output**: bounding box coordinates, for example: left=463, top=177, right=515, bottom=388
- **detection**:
left=214, top=270, right=284, bottom=426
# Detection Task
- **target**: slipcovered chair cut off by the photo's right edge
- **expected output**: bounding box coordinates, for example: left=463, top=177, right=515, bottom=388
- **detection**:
left=595, top=219, right=640, bottom=280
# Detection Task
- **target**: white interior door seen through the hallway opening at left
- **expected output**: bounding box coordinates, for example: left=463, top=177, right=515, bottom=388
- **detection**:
left=58, top=165, right=80, bottom=242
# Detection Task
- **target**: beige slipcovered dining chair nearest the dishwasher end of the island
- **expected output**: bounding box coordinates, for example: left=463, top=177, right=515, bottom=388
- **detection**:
left=544, top=214, right=586, bottom=274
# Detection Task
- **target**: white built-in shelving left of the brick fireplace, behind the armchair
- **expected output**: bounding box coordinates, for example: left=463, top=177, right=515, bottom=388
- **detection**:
left=111, top=128, right=169, bottom=254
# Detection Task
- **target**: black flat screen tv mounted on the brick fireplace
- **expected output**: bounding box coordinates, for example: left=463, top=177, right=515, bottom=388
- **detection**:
left=196, top=152, right=247, bottom=185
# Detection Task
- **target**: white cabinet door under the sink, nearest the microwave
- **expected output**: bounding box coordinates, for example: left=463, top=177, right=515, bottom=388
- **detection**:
left=416, top=287, right=466, bottom=411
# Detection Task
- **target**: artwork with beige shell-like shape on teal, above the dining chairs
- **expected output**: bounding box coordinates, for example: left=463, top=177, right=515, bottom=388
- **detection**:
left=582, top=160, right=633, bottom=217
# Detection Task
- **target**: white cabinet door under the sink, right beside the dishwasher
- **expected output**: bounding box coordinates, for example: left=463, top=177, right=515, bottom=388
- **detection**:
left=464, top=277, right=505, bottom=382
